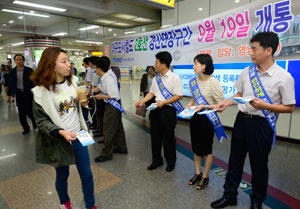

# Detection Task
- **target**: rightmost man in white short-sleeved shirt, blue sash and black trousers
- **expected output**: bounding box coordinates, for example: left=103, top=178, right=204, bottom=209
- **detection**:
left=211, top=32, right=296, bottom=209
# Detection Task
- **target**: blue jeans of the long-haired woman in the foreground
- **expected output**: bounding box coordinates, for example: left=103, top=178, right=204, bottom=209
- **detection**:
left=55, top=140, right=95, bottom=209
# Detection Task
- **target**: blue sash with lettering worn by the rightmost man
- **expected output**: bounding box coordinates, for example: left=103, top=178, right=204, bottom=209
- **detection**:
left=249, top=65, right=278, bottom=147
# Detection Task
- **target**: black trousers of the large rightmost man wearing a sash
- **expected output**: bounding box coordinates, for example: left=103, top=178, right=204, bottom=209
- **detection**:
left=224, top=112, right=273, bottom=203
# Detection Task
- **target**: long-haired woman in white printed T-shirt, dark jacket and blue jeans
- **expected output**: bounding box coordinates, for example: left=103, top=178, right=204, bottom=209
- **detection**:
left=31, top=47, right=97, bottom=209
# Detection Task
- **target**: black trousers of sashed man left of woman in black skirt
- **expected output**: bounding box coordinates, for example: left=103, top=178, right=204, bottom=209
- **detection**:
left=150, top=105, right=177, bottom=165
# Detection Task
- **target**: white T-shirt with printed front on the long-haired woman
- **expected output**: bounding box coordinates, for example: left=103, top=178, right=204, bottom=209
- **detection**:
left=50, top=80, right=81, bottom=133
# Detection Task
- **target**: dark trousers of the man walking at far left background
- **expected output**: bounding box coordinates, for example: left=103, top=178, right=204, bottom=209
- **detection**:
left=16, top=89, right=36, bottom=130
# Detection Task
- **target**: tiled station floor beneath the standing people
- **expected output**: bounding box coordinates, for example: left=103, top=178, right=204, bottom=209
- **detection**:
left=0, top=81, right=300, bottom=209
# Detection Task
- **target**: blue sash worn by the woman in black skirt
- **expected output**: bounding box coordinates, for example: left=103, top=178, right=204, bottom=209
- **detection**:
left=189, top=78, right=228, bottom=142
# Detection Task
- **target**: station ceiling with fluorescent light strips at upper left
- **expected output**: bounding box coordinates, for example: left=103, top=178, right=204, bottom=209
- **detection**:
left=0, top=0, right=161, bottom=50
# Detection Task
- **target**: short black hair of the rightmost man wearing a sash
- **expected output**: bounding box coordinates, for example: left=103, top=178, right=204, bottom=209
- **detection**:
left=250, top=32, right=279, bottom=55
